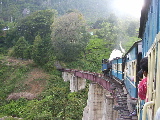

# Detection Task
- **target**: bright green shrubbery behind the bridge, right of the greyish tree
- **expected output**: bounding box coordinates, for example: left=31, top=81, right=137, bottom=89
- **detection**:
left=84, top=37, right=111, bottom=72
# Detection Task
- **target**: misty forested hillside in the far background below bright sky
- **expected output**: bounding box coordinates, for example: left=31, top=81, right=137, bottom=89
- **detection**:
left=0, top=0, right=136, bottom=22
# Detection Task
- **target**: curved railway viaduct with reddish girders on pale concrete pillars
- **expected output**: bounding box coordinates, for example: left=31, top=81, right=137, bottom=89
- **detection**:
left=60, top=69, right=136, bottom=120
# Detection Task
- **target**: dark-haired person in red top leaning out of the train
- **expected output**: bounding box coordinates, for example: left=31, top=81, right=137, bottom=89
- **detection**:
left=138, top=57, right=148, bottom=100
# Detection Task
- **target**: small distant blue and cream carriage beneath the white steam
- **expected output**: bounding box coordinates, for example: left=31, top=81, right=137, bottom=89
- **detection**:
left=112, top=57, right=123, bottom=81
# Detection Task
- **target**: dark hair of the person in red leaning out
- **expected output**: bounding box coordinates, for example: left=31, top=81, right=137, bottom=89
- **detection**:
left=140, top=57, right=148, bottom=73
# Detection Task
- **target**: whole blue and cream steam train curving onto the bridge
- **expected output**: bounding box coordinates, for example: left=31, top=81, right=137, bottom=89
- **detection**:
left=102, top=0, right=160, bottom=120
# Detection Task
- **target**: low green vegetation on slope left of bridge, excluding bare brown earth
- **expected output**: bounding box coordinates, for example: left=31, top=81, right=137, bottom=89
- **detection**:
left=0, top=56, right=87, bottom=120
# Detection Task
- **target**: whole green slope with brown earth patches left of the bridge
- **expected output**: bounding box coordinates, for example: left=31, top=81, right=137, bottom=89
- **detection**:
left=0, top=56, right=88, bottom=120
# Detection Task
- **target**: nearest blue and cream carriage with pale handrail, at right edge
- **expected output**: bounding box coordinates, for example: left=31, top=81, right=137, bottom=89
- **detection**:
left=139, top=0, right=160, bottom=120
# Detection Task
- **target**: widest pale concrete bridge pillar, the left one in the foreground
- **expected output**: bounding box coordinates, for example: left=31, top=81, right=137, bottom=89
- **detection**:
left=82, top=83, right=104, bottom=120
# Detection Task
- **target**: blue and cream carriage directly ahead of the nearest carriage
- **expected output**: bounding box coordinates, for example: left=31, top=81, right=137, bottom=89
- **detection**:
left=124, top=40, right=142, bottom=99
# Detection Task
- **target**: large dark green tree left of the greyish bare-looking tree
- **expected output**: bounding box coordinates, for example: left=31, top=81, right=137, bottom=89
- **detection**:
left=17, top=10, right=56, bottom=44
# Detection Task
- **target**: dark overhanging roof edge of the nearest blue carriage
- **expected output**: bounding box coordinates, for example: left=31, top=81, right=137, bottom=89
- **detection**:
left=138, top=0, right=152, bottom=38
